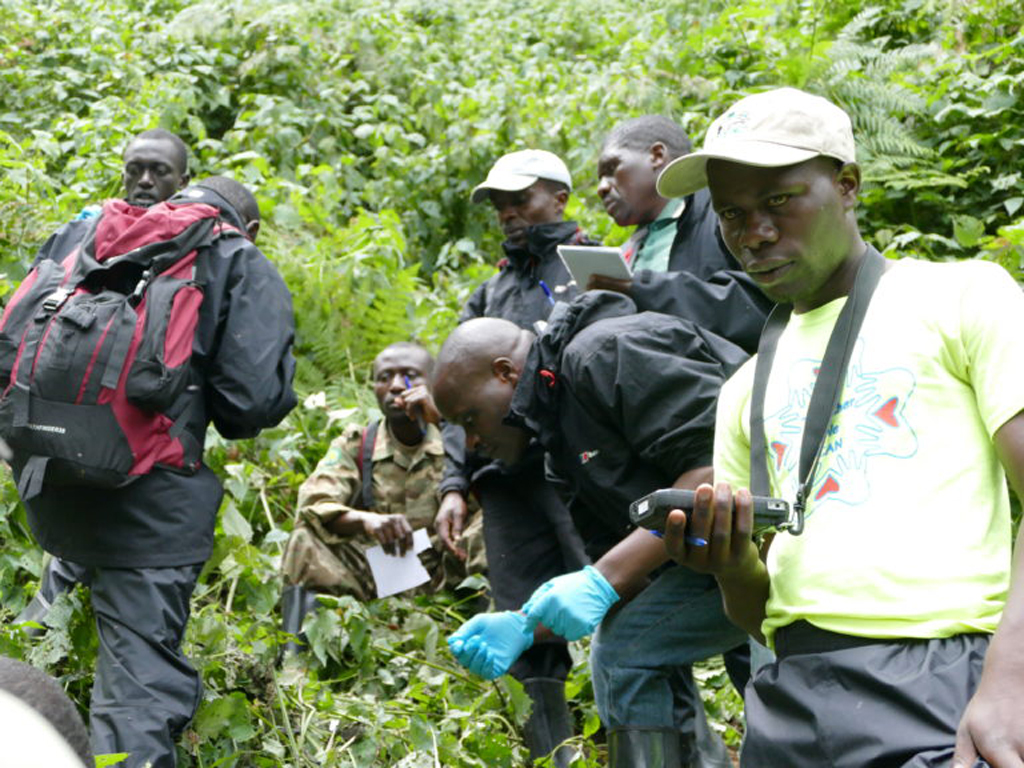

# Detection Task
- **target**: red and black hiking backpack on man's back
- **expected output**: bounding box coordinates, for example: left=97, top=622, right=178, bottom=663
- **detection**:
left=0, top=200, right=241, bottom=499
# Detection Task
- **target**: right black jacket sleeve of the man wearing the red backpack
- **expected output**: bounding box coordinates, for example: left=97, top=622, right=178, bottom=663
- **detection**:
left=206, top=241, right=296, bottom=439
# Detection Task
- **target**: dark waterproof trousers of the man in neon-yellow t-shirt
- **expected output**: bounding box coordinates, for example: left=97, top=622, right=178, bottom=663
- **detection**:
left=740, top=622, right=990, bottom=768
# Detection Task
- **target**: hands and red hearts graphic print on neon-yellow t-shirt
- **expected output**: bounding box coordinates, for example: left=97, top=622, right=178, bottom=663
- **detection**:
left=765, top=339, right=918, bottom=515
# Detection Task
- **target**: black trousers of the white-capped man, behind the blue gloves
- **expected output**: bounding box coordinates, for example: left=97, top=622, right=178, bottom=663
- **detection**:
left=474, top=462, right=590, bottom=680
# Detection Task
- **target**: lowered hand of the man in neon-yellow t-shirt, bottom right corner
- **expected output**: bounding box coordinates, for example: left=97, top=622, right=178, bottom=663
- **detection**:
left=951, top=651, right=1024, bottom=768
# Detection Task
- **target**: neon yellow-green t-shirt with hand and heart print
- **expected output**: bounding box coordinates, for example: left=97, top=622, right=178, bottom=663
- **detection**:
left=715, top=259, right=1024, bottom=641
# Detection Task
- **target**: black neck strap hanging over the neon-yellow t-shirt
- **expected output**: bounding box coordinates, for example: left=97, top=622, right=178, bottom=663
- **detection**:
left=750, top=246, right=886, bottom=536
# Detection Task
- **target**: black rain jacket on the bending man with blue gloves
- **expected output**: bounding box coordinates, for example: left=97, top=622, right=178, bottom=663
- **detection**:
left=507, top=291, right=748, bottom=560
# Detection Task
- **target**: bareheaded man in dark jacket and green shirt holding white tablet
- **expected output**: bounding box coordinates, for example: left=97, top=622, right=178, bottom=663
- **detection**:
left=588, top=115, right=772, bottom=352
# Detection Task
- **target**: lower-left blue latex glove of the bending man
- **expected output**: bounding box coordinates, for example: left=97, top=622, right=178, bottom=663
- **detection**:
left=449, top=610, right=534, bottom=680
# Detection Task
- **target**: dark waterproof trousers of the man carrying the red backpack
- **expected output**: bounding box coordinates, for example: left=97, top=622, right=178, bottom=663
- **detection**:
left=71, top=561, right=203, bottom=768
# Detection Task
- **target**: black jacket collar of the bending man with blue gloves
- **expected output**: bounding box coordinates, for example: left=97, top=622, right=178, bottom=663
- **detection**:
left=505, top=291, right=637, bottom=447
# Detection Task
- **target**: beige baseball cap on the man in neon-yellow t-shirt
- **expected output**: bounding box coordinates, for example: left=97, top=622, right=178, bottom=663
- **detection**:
left=657, top=88, right=857, bottom=198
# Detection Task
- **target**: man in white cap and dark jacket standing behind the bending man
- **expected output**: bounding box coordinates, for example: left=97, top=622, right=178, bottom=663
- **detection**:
left=436, top=150, right=596, bottom=766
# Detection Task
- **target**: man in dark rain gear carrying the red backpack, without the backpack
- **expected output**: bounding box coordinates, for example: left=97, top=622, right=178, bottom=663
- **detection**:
left=11, top=177, right=296, bottom=768
